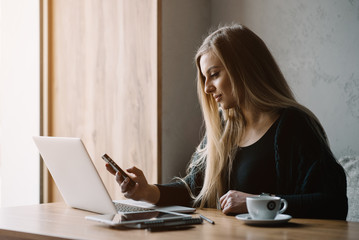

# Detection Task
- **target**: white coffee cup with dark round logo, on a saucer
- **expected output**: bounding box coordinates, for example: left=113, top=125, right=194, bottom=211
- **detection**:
left=246, top=196, right=288, bottom=220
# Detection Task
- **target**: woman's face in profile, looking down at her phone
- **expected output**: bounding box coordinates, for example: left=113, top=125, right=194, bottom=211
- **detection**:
left=200, top=51, right=236, bottom=109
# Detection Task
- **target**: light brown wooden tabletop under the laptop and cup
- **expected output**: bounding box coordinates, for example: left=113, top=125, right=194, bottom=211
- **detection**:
left=0, top=203, right=359, bottom=240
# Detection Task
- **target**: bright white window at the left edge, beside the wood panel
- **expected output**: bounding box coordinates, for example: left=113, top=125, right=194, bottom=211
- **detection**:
left=0, top=0, right=40, bottom=206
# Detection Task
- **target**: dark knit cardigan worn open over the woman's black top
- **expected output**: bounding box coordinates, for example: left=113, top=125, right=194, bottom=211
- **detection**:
left=157, top=108, right=348, bottom=220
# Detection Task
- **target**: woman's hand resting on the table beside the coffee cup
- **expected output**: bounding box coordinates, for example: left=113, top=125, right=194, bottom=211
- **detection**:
left=220, top=190, right=255, bottom=214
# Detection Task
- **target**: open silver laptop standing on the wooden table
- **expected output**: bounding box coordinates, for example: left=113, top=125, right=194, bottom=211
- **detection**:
left=33, top=137, right=195, bottom=214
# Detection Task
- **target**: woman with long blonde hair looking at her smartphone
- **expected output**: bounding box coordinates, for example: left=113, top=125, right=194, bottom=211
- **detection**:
left=106, top=25, right=348, bottom=219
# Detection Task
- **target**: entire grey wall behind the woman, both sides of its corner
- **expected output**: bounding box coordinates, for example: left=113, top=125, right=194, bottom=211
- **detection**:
left=162, top=0, right=359, bottom=182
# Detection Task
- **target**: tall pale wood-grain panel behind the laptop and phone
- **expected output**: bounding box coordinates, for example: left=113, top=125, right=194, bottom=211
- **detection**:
left=48, top=0, right=161, bottom=202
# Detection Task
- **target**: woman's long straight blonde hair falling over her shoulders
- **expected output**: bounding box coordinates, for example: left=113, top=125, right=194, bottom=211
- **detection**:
left=187, top=24, right=328, bottom=208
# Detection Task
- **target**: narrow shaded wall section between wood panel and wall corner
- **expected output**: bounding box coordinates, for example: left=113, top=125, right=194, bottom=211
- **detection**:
left=161, top=0, right=210, bottom=182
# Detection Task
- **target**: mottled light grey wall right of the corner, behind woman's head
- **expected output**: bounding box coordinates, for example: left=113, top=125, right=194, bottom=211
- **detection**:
left=211, top=0, right=359, bottom=157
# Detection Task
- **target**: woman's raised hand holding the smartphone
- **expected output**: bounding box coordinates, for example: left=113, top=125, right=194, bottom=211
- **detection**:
left=106, top=164, right=160, bottom=204
